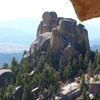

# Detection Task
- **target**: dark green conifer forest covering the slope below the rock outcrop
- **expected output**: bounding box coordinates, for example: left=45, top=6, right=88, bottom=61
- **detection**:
left=0, top=46, right=100, bottom=100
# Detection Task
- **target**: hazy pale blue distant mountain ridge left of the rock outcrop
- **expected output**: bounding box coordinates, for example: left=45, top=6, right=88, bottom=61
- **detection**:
left=0, top=18, right=40, bottom=44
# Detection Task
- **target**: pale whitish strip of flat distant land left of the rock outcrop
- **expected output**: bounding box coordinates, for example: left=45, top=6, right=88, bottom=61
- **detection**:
left=0, top=43, right=29, bottom=53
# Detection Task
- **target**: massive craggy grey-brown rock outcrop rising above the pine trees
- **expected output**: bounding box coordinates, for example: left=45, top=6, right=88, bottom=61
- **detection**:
left=24, top=12, right=90, bottom=59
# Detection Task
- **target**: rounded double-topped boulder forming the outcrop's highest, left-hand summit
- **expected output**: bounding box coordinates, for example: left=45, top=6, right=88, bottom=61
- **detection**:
left=37, top=12, right=58, bottom=36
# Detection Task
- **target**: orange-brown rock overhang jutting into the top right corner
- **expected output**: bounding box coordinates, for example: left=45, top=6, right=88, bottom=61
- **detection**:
left=70, top=0, right=100, bottom=21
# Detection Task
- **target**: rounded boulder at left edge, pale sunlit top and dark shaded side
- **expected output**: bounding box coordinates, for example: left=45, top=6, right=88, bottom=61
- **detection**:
left=0, top=69, right=14, bottom=88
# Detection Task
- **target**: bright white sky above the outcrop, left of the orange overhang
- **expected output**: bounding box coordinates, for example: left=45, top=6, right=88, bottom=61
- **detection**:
left=0, top=0, right=77, bottom=21
